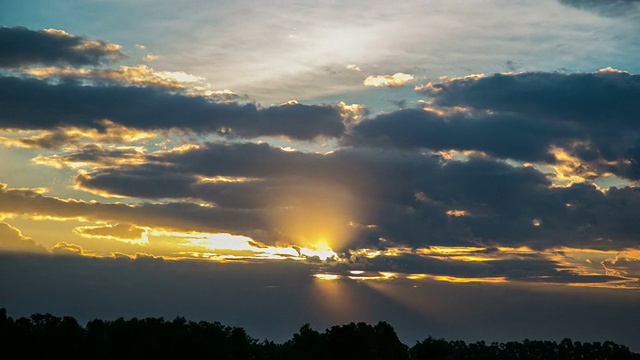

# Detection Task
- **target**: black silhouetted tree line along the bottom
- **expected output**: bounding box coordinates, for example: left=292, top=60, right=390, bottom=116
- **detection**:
left=0, top=309, right=640, bottom=360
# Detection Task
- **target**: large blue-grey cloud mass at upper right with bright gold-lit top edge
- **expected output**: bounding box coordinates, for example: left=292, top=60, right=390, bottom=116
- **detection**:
left=356, top=69, right=640, bottom=180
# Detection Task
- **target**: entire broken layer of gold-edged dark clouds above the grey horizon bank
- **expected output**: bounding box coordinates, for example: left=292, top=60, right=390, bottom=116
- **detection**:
left=0, top=28, right=640, bottom=287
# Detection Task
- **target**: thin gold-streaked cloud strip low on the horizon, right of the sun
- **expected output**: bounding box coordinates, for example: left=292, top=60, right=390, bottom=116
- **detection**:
left=326, top=246, right=638, bottom=288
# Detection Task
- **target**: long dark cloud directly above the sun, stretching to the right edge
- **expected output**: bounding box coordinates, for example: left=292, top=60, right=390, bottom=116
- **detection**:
left=65, top=143, right=640, bottom=249
